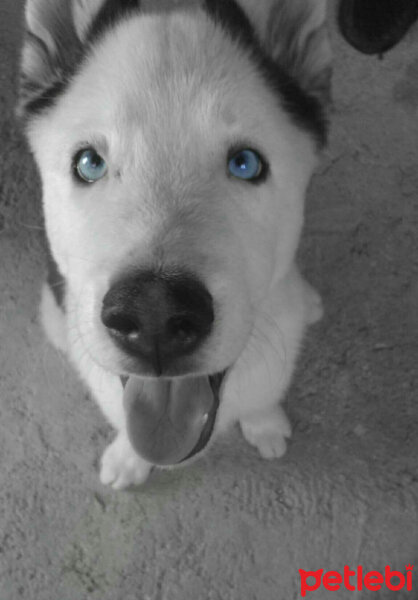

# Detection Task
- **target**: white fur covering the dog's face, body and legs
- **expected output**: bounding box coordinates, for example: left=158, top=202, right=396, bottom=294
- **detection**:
left=22, top=0, right=330, bottom=489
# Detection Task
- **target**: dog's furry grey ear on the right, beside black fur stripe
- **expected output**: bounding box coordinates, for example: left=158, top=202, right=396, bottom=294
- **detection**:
left=261, top=0, right=332, bottom=105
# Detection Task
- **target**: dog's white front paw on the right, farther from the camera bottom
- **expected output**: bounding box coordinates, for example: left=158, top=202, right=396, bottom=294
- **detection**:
left=240, top=406, right=292, bottom=458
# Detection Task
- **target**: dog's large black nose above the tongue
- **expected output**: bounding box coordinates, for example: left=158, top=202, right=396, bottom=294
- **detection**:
left=101, top=271, right=214, bottom=375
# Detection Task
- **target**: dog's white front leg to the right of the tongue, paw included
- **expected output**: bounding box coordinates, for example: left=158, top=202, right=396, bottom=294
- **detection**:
left=219, top=267, right=322, bottom=458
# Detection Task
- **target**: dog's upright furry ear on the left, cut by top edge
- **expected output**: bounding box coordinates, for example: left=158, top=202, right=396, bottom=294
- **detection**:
left=17, top=0, right=104, bottom=117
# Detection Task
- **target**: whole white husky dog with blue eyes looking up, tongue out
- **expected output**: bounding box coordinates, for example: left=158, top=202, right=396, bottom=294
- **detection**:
left=18, top=0, right=331, bottom=489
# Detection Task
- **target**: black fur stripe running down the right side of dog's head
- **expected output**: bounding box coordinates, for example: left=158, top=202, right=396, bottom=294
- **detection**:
left=204, top=0, right=327, bottom=146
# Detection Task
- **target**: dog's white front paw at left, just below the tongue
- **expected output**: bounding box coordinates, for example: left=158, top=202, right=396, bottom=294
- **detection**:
left=100, top=433, right=152, bottom=490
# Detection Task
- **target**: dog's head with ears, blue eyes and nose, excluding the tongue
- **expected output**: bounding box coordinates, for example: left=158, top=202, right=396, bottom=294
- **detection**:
left=21, top=0, right=329, bottom=376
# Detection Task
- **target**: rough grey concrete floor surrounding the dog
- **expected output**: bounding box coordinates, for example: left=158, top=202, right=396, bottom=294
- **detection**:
left=0, top=0, right=418, bottom=600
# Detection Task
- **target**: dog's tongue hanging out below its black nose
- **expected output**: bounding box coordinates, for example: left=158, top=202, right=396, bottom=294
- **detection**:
left=124, top=376, right=214, bottom=465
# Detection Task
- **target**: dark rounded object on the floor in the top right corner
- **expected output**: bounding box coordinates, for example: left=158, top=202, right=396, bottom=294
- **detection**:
left=338, top=0, right=418, bottom=54
